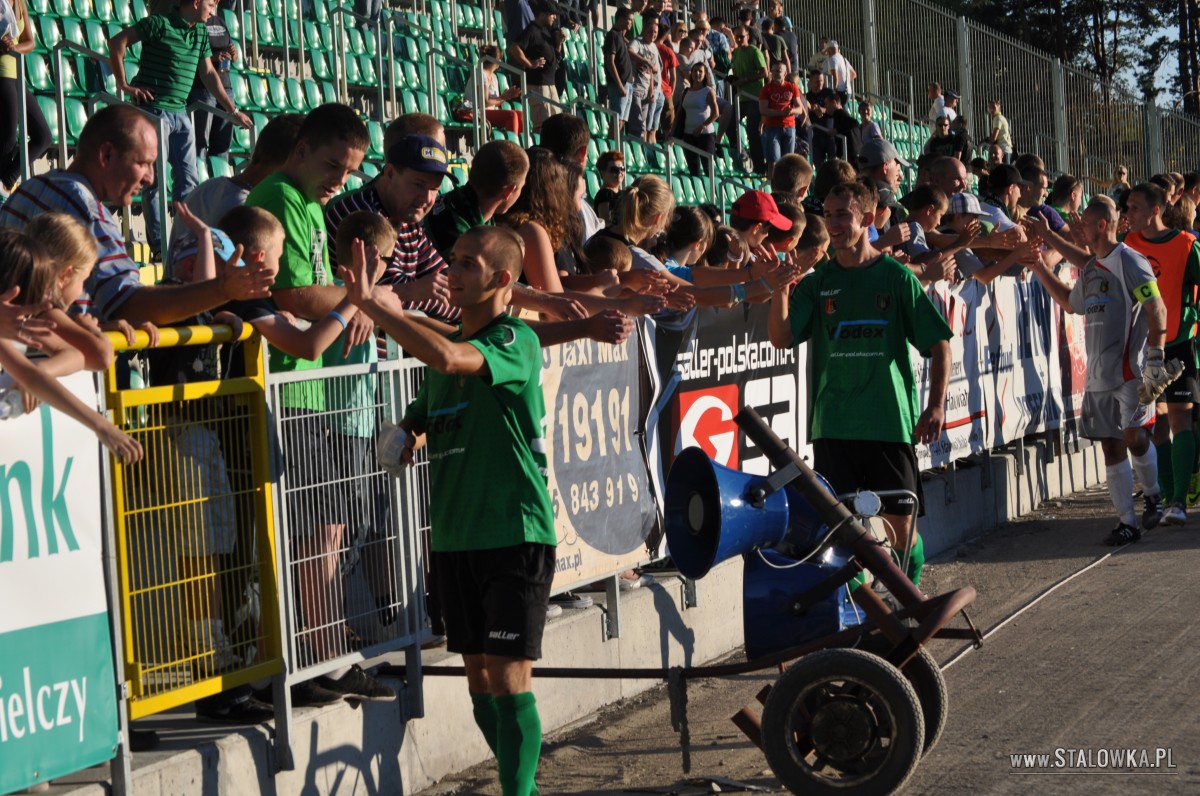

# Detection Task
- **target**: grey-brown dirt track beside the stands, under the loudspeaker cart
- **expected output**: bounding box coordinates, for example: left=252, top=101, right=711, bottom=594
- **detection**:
left=426, top=489, right=1200, bottom=796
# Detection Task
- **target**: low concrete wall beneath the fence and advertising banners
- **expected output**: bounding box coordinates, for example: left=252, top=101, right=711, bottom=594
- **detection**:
left=64, top=443, right=1104, bottom=796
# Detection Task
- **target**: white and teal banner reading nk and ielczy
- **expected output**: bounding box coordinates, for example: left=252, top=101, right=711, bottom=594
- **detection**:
left=0, top=373, right=118, bottom=792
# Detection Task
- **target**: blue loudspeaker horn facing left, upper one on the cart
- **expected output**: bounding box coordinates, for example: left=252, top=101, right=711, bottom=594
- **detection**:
left=665, top=448, right=798, bottom=577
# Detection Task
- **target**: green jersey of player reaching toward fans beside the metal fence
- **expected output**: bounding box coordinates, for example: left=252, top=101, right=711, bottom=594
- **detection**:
left=404, top=315, right=557, bottom=552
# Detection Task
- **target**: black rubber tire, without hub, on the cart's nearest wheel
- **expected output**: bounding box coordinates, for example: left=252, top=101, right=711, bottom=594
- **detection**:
left=762, top=650, right=925, bottom=796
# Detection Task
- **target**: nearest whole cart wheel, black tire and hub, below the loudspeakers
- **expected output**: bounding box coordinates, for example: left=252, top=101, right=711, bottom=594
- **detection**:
left=762, top=650, right=925, bottom=796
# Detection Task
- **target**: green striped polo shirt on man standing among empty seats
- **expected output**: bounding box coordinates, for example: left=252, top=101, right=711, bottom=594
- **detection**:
left=131, top=11, right=212, bottom=110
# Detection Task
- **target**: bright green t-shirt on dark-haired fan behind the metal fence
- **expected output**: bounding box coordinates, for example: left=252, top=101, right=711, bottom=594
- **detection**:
left=246, top=172, right=336, bottom=412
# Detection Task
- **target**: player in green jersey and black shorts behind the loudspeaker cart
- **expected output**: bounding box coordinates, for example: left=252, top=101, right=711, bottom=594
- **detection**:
left=769, top=182, right=952, bottom=583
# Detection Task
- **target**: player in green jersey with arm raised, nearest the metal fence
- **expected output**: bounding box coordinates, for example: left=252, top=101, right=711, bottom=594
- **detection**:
left=342, top=227, right=556, bottom=796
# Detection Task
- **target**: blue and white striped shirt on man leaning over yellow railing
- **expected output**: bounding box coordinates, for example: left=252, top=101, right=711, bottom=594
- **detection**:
left=0, top=168, right=140, bottom=321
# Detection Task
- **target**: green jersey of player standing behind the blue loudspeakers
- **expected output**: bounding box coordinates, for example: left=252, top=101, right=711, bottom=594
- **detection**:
left=788, top=256, right=953, bottom=443
